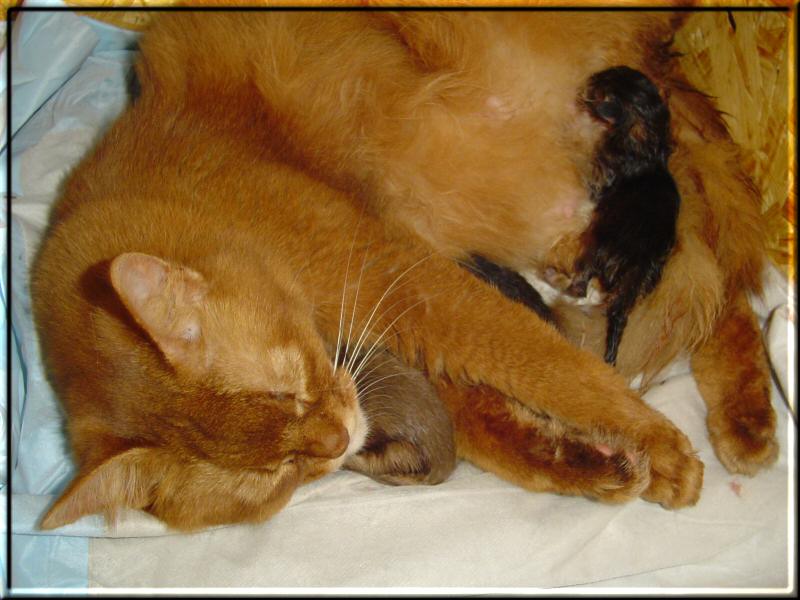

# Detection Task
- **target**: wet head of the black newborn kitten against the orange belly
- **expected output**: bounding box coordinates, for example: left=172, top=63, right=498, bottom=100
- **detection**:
left=580, top=66, right=670, bottom=169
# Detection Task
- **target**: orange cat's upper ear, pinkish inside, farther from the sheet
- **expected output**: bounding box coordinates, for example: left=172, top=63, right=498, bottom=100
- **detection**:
left=110, top=252, right=208, bottom=372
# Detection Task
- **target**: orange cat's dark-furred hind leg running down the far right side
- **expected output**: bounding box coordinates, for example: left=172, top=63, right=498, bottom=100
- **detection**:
left=648, top=67, right=777, bottom=475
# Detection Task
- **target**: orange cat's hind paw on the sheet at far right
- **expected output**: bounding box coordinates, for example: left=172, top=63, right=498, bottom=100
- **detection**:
left=707, top=392, right=778, bottom=475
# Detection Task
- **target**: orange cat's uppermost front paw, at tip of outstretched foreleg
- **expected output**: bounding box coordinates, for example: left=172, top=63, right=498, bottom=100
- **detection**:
left=642, top=422, right=704, bottom=509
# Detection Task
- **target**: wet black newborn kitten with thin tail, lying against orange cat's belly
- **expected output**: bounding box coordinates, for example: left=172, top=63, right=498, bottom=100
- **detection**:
left=566, top=66, right=680, bottom=364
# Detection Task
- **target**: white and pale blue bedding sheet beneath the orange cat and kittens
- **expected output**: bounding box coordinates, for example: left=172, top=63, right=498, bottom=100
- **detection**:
left=0, top=7, right=796, bottom=593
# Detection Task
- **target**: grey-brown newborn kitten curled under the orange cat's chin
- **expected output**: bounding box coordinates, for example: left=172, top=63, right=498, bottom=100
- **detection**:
left=344, top=350, right=456, bottom=485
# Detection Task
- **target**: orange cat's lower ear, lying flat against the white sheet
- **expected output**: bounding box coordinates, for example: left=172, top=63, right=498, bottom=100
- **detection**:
left=39, top=448, right=164, bottom=529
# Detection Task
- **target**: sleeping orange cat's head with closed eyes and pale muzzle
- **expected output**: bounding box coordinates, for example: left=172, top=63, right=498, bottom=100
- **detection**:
left=41, top=253, right=366, bottom=530
